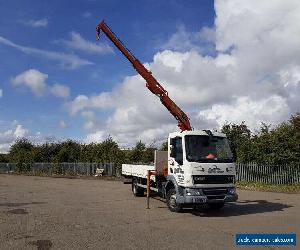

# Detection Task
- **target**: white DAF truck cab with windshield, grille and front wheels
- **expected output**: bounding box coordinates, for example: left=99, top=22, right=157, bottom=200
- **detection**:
left=165, top=130, right=238, bottom=211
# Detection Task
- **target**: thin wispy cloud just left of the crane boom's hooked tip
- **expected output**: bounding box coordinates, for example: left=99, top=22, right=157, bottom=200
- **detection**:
left=58, top=31, right=113, bottom=54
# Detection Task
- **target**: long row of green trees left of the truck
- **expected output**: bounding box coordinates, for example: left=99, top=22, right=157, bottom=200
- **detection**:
left=0, top=137, right=157, bottom=169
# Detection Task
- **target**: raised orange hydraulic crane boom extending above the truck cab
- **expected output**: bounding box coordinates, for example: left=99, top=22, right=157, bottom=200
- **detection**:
left=96, top=21, right=192, bottom=131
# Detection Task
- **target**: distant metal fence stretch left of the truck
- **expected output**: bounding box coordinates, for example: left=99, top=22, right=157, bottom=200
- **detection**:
left=0, top=162, right=120, bottom=176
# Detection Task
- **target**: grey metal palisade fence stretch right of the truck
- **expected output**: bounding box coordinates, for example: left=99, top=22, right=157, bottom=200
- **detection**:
left=236, top=163, right=300, bottom=185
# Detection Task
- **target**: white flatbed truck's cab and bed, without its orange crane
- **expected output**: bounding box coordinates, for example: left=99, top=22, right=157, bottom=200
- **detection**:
left=122, top=130, right=238, bottom=212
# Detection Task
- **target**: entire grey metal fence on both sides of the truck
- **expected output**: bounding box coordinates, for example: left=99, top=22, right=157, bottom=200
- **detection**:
left=0, top=163, right=300, bottom=185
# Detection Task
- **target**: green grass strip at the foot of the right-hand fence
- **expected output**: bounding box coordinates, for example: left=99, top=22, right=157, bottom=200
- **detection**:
left=236, top=182, right=300, bottom=193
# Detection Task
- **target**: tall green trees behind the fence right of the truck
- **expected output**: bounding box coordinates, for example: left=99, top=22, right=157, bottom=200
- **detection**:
left=222, top=113, right=300, bottom=165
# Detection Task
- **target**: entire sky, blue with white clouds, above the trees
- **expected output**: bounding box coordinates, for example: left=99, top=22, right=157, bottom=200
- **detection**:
left=0, top=0, right=299, bottom=152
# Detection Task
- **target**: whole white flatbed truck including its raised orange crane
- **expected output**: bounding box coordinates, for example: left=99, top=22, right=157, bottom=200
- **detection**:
left=96, top=21, right=238, bottom=212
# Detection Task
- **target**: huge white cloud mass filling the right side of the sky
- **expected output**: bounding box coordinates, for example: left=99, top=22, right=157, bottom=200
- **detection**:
left=67, top=0, right=300, bottom=146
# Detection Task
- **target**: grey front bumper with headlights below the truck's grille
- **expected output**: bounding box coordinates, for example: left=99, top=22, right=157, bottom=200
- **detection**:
left=176, top=188, right=238, bottom=204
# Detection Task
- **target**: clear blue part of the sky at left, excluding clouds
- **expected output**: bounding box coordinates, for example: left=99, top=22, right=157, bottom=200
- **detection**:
left=0, top=0, right=214, bottom=148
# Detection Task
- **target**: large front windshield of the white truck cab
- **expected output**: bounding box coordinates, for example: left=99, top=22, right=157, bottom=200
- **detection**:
left=185, top=135, right=233, bottom=162
